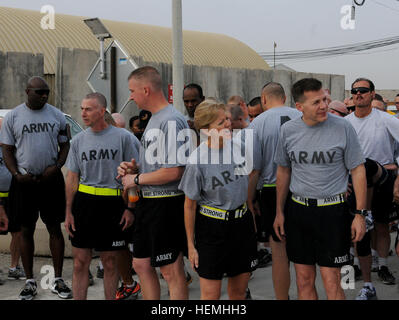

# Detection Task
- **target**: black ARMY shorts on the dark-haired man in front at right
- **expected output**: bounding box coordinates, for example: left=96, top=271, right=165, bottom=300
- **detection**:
left=284, top=198, right=352, bottom=268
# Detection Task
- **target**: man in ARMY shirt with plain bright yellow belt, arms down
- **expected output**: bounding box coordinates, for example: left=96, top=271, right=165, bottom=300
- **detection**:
left=65, top=93, right=139, bottom=300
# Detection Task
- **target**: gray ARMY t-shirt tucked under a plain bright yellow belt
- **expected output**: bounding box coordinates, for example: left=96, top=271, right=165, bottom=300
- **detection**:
left=66, top=125, right=140, bottom=189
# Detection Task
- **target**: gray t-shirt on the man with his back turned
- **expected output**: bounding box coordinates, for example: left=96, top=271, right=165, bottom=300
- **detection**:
left=249, top=106, right=302, bottom=190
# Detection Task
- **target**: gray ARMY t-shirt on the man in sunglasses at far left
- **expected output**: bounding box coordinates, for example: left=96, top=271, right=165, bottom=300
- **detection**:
left=0, top=103, right=68, bottom=175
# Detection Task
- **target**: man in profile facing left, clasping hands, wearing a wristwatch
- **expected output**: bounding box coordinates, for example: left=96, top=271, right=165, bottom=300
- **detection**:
left=118, top=66, right=188, bottom=300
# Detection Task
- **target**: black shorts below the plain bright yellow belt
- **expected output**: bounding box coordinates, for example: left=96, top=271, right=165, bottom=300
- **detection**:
left=70, top=191, right=128, bottom=251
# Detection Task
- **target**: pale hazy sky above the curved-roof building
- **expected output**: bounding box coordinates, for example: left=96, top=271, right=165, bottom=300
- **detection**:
left=0, top=0, right=399, bottom=92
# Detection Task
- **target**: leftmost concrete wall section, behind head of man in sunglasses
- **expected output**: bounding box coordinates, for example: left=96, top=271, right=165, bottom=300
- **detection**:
left=0, top=51, right=44, bottom=109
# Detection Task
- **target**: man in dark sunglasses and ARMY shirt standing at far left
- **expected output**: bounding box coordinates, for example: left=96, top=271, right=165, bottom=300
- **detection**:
left=0, top=77, right=72, bottom=300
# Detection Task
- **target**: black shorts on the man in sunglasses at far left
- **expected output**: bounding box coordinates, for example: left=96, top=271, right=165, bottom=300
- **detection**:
left=8, top=170, right=65, bottom=232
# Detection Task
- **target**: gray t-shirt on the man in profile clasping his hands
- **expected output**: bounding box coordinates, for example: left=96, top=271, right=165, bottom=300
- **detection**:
left=139, top=105, right=193, bottom=191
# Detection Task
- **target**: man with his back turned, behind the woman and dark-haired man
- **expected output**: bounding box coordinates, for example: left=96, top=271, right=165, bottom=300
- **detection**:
left=248, top=82, right=301, bottom=300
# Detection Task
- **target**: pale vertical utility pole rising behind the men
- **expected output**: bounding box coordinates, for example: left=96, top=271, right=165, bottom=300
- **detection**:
left=172, top=0, right=186, bottom=114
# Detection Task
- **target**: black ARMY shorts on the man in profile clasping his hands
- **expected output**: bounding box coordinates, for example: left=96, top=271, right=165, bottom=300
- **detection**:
left=133, top=195, right=187, bottom=267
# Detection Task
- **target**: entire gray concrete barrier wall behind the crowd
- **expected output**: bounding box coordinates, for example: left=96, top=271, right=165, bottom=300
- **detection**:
left=0, top=48, right=345, bottom=124
